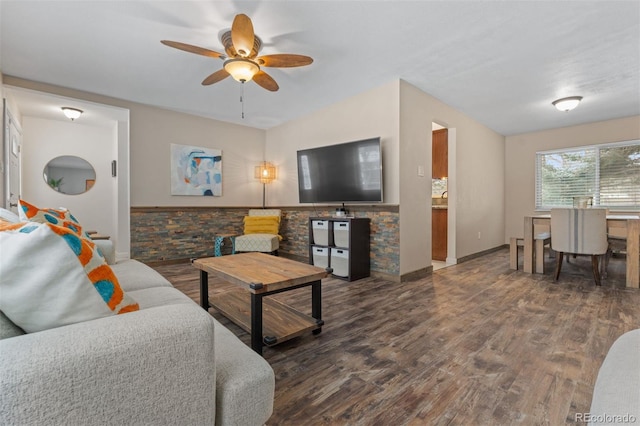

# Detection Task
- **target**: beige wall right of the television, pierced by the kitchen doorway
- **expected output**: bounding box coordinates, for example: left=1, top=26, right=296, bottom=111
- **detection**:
left=400, top=82, right=505, bottom=273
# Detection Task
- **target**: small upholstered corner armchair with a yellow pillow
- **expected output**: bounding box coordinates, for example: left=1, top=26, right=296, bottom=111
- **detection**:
left=235, top=209, right=282, bottom=255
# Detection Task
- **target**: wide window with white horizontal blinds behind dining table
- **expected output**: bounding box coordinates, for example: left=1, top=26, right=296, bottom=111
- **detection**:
left=536, top=141, right=640, bottom=210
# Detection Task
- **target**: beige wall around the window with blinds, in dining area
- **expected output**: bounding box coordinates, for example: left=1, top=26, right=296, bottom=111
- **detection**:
left=504, top=116, right=640, bottom=243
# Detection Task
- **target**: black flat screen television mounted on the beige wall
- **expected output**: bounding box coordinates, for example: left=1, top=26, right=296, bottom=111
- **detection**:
left=298, top=137, right=382, bottom=203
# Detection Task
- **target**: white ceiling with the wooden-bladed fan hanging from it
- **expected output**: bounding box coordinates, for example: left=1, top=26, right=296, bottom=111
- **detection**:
left=0, top=0, right=640, bottom=135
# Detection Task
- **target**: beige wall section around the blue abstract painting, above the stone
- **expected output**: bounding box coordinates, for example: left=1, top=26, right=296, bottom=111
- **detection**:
left=4, top=76, right=265, bottom=207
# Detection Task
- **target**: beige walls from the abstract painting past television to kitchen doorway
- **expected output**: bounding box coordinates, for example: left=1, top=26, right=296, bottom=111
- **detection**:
left=4, top=76, right=524, bottom=274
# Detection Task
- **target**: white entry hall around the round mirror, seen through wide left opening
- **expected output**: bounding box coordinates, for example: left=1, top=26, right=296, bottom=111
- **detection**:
left=3, top=86, right=131, bottom=260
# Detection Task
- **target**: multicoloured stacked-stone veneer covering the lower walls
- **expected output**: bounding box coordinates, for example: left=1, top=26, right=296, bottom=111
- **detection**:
left=131, top=205, right=400, bottom=276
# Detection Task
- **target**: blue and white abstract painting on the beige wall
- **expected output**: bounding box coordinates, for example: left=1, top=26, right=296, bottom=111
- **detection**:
left=171, top=144, right=222, bottom=197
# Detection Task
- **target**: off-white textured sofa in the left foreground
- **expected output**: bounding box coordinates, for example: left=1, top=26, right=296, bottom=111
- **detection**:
left=0, top=260, right=275, bottom=426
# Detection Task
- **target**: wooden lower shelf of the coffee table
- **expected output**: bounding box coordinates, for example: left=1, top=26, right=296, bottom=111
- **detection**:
left=209, top=290, right=323, bottom=346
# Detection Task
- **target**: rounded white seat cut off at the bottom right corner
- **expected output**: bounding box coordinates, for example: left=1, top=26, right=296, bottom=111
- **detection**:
left=583, top=329, right=640, bottom=426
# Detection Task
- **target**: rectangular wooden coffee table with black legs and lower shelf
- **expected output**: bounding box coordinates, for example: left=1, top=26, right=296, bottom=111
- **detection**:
left=193, top=253, right=330, bottom=354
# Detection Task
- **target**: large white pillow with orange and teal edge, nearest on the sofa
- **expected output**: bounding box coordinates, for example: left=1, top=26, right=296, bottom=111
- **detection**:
left=0, top=222, right=139, bottom=333
